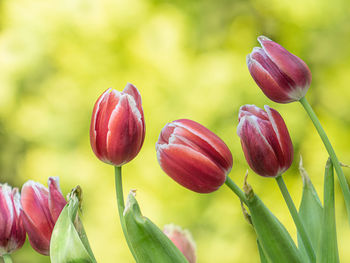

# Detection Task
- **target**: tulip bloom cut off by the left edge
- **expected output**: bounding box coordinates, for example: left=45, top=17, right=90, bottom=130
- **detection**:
left=0, top=184, right=26, bottom=256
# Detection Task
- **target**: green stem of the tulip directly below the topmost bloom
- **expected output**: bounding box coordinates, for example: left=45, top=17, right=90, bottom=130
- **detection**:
left=276, top=175, right=316, bottom=263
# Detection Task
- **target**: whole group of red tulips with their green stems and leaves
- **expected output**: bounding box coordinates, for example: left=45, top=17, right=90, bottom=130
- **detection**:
left=0, top=36, right=350, bottom=263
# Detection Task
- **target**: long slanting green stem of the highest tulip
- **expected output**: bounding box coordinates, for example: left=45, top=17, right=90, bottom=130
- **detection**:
left=300, top=97, right=350, bottom=223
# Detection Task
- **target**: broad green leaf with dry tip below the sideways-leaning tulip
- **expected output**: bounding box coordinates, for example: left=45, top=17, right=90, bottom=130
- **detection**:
left=244, top=177, right=303, bottom=263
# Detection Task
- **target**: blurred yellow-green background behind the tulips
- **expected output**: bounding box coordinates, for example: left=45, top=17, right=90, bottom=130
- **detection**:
left=0, top=0, right=350, bottom=263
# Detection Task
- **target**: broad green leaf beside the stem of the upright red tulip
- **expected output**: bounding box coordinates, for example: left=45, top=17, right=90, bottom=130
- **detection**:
left=124, top=191, right=188, bottom=263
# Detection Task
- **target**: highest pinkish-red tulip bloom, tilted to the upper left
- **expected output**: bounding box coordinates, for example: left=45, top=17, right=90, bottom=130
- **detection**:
left=247, top=36, right=311, bottom=103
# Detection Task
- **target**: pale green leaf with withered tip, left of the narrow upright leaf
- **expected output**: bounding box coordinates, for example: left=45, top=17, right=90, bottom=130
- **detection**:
left=298, top=156, right=323, bottom=260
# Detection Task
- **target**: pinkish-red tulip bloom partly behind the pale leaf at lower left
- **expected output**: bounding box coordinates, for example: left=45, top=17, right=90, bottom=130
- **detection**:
left=21, top=177, right=66, bottom=255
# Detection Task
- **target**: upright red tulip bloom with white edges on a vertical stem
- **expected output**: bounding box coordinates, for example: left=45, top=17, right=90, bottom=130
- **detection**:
left=90, top=83, right=145, bottom=166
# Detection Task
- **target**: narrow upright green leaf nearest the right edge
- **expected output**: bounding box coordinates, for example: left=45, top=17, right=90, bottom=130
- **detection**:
left=317, top=159, right=339, bottom=263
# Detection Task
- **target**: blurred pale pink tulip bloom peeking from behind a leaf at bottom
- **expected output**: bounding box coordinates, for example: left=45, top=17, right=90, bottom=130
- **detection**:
left=163, top=224, right=196, bottom=263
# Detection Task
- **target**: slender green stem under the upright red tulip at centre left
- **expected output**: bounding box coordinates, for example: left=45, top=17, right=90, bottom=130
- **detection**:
left=114, top=166, right=137, bottom=262
